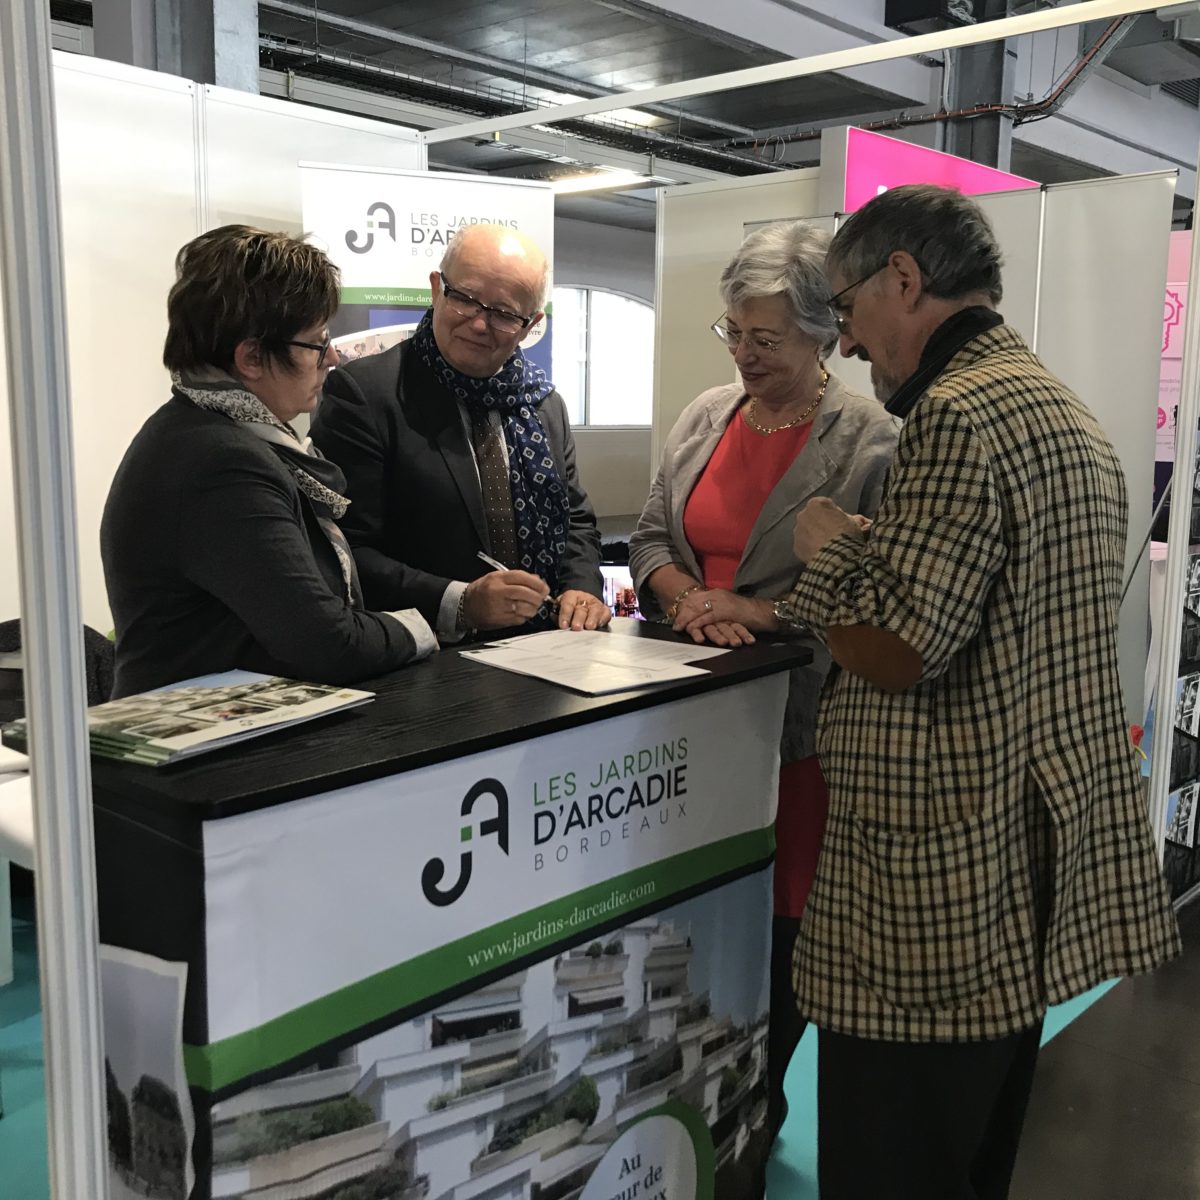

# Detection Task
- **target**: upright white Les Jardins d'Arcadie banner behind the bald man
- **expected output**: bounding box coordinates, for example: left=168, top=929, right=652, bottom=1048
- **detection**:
left=300, top=163, right=554, bottom=374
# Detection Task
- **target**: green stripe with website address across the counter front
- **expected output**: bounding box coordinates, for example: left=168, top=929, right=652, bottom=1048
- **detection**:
left=184, top=828, right=775, bottom=1092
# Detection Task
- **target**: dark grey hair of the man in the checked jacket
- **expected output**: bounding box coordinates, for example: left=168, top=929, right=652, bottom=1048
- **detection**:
left=828, top=184, right=1004, bottom=304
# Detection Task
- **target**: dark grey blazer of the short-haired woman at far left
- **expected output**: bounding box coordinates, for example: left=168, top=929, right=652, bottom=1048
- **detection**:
left=100, top=396, right=416, bottom=697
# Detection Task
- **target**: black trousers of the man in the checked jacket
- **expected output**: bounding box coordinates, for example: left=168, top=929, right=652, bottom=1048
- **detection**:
left=817, top=1021, right=1042, bottom=1200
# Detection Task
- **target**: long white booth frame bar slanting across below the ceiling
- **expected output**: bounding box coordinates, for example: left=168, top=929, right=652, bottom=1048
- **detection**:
left=424, top=0, right=1160, bottom=144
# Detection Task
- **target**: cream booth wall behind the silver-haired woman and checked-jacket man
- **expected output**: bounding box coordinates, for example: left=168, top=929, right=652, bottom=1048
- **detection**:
left=653, top=159, right=1175, bottom=724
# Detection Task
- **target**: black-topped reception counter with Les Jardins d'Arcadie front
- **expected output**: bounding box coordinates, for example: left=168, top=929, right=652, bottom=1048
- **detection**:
left=94, top=622, right=810, bottom=1200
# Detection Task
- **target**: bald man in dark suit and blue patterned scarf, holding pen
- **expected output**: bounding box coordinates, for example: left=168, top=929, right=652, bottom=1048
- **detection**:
left=312, top=226, right=612, bottom=641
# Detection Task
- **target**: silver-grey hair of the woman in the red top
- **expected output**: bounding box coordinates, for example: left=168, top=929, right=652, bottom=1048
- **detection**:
left=720, top=221, right=838, bottom=358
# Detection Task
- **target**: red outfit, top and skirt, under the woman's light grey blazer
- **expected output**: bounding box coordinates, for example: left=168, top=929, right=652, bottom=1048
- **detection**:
left=683, top=412, right=829, bottom=917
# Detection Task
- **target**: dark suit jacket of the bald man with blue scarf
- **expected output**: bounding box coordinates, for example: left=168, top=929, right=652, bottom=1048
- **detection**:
left=312, top=342, right=602, bottom=625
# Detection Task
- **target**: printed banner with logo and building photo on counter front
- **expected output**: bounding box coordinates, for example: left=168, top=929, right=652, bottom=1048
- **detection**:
left=185, top=676, right=787, bottom=1200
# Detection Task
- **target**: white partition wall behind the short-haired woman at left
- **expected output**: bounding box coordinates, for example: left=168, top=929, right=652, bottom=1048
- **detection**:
left=0, top=54, right=425, bottom=632
